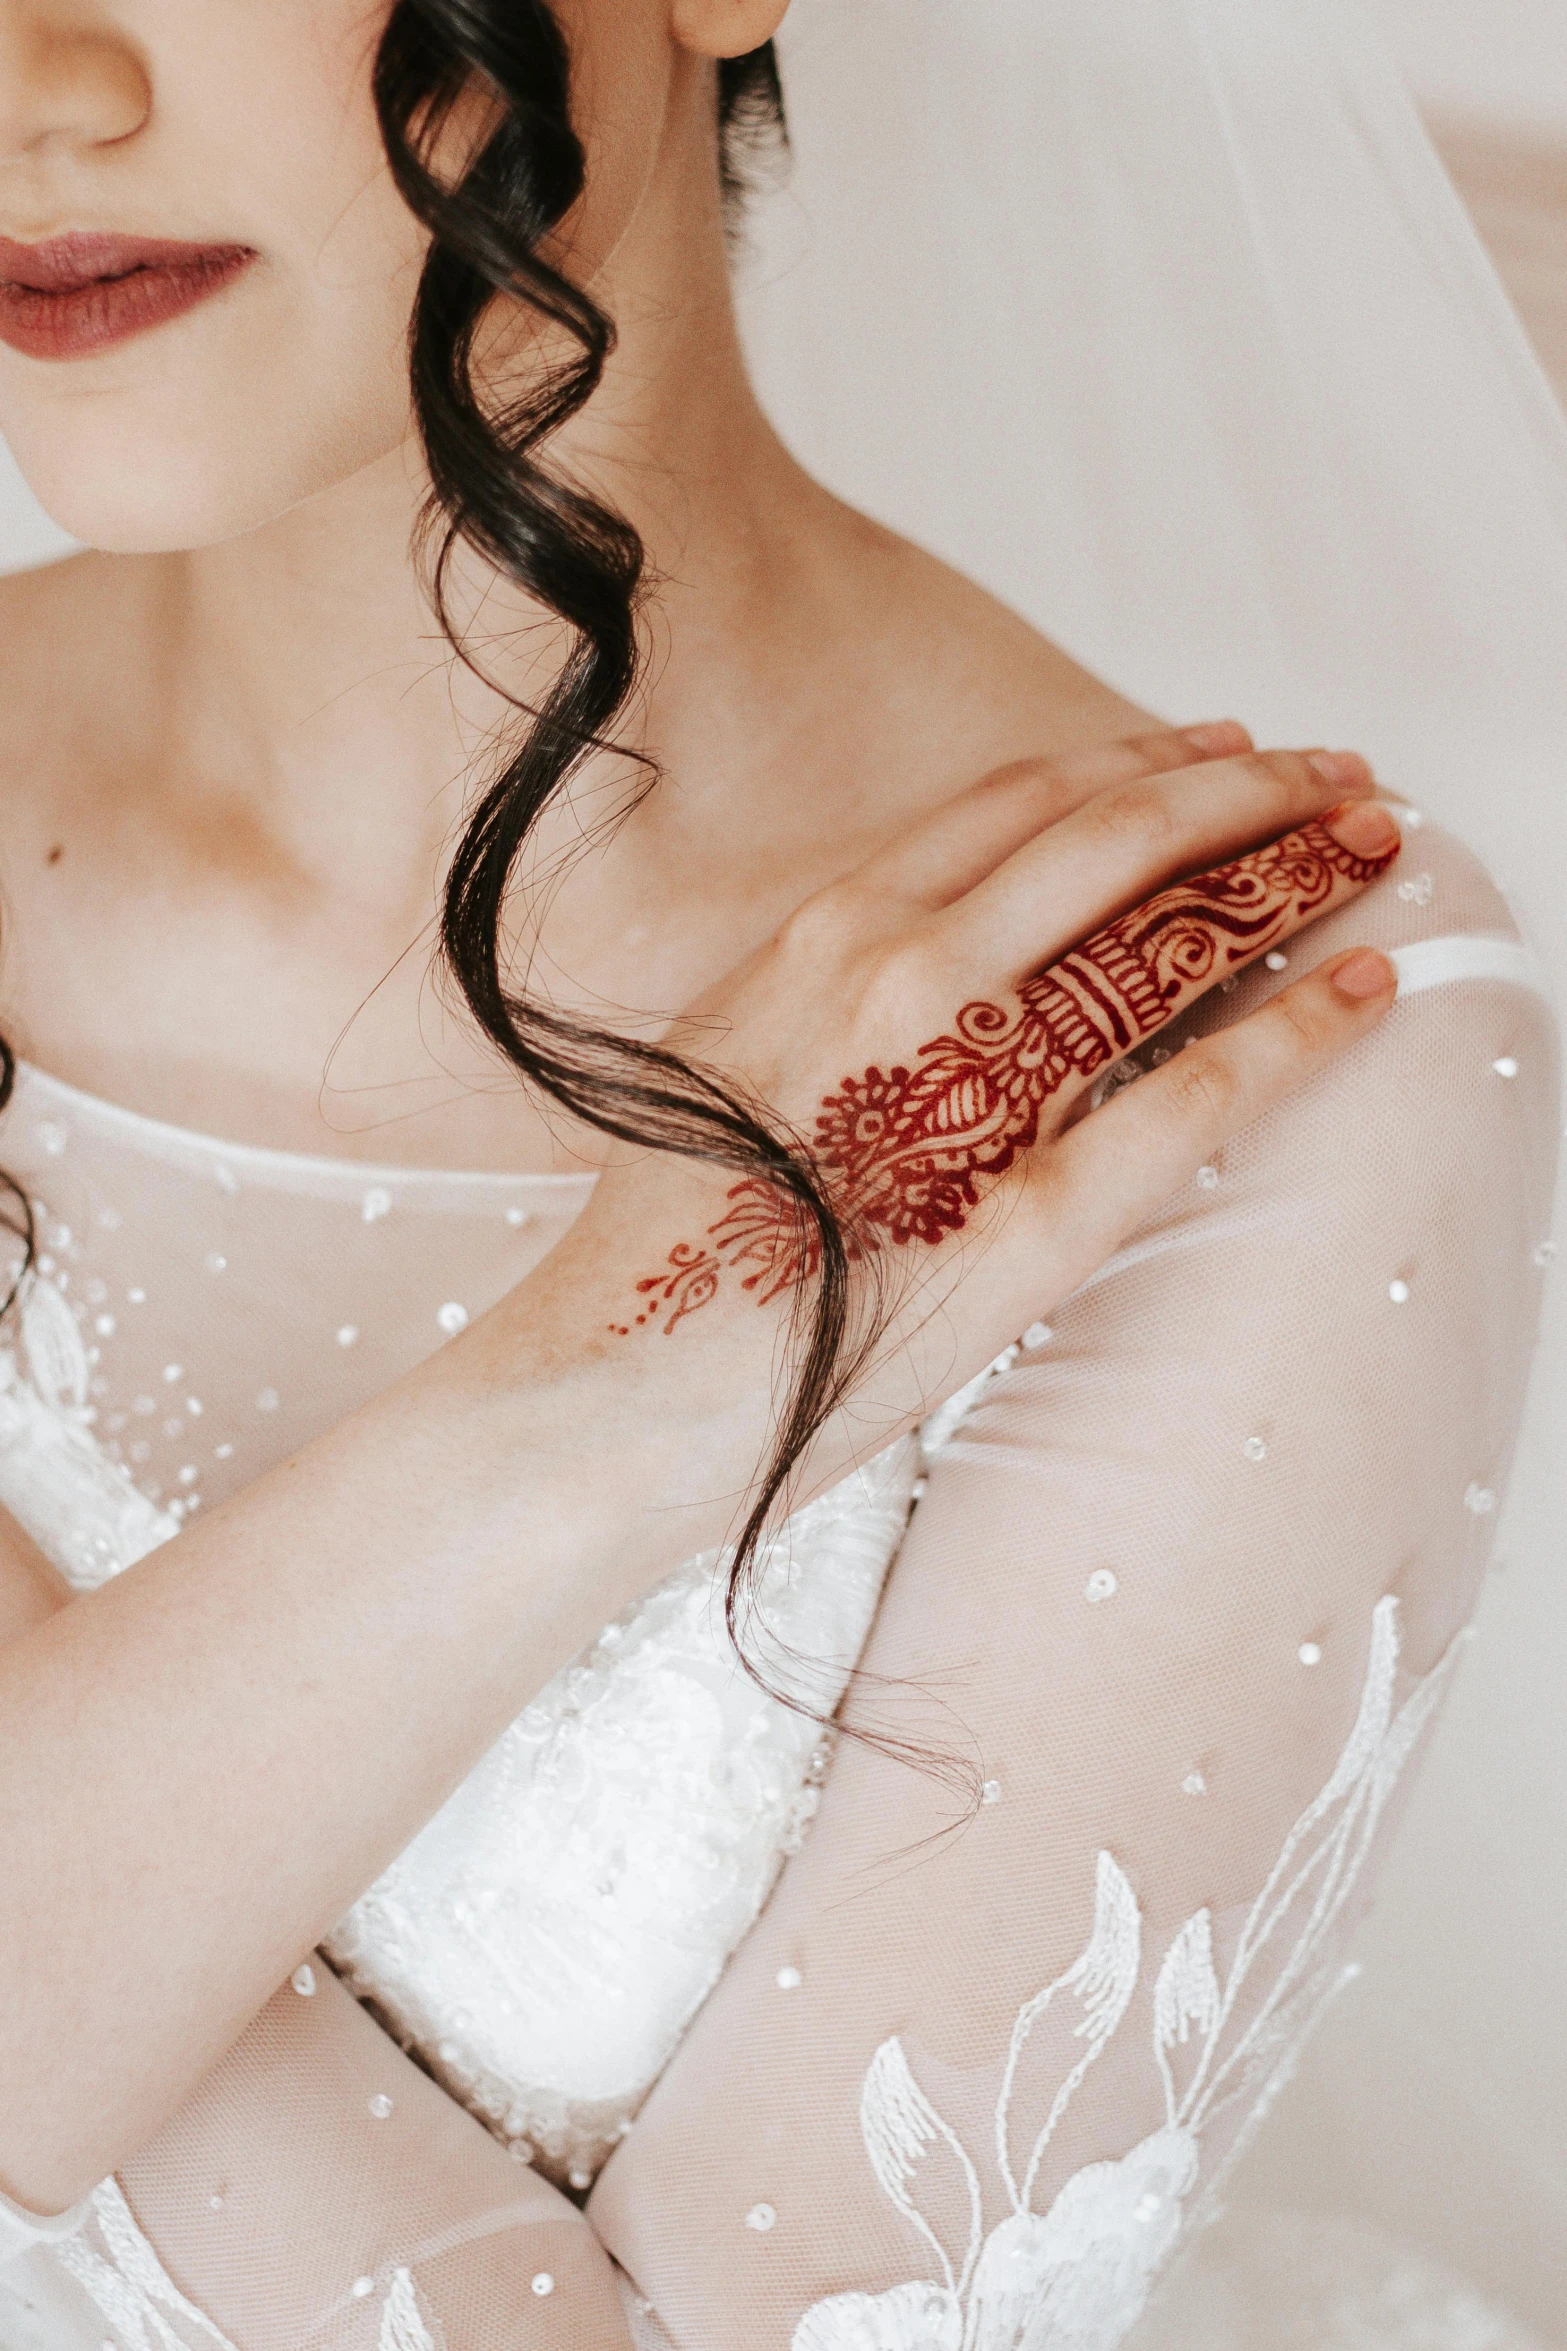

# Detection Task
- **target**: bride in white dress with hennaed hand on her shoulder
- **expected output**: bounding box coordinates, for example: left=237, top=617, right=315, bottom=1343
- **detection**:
left=0, top=0, right=1555, bottom=2351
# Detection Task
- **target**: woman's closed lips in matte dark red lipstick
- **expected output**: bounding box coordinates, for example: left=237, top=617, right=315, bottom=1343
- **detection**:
left=0, top=235, right=256, bottom=360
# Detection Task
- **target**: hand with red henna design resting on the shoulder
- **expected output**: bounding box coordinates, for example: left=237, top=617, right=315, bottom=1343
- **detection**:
left=540, top=729, right=1398, bottom=1483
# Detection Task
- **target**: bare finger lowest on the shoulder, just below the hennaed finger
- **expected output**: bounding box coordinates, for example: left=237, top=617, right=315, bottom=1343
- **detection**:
left=1024, top=947, right=1398, bottom=1286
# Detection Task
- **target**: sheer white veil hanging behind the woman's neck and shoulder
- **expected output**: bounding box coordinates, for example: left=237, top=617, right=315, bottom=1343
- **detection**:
left=747, top=0, right=1567, bottom=2318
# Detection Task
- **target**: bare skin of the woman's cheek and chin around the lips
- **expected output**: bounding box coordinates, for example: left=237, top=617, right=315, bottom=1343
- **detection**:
left=0, top=0, right=423, bottom=552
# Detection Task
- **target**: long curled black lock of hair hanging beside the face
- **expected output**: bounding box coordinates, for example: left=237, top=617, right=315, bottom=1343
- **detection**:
left=374, top=0, right=865, bottom=1712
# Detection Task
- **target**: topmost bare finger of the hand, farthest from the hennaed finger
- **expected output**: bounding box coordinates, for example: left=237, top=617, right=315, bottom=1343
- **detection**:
left=853, top=719, right=1252, bottom=910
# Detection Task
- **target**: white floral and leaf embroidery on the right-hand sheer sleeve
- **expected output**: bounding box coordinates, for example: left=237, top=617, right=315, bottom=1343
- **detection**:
left=792, top=1599, right=1464, bottom=2351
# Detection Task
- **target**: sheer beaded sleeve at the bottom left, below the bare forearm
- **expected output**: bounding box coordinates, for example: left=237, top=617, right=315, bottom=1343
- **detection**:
left=0, top=1961, right=630, bottom=2351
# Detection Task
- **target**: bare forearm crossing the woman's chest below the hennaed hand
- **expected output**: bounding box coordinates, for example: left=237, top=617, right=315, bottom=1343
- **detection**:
left=0, top=1260, right=751, bottom=2210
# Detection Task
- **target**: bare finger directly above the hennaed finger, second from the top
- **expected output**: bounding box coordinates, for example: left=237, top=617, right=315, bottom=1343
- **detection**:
left=942, top=750, right=1374, bottom=985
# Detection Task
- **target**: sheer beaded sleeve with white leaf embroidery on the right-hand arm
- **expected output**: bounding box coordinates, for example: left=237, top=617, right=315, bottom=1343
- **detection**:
left=590, top=830, right=1555, bottom=2351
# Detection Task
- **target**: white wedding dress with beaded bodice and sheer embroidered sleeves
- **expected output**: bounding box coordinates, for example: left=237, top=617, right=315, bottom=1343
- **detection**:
left=0, top=823, right=1558, bottom=2351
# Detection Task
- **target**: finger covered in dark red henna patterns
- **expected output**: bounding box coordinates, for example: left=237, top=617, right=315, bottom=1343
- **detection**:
left=1013, top=802, right=1400, bottom=1128
